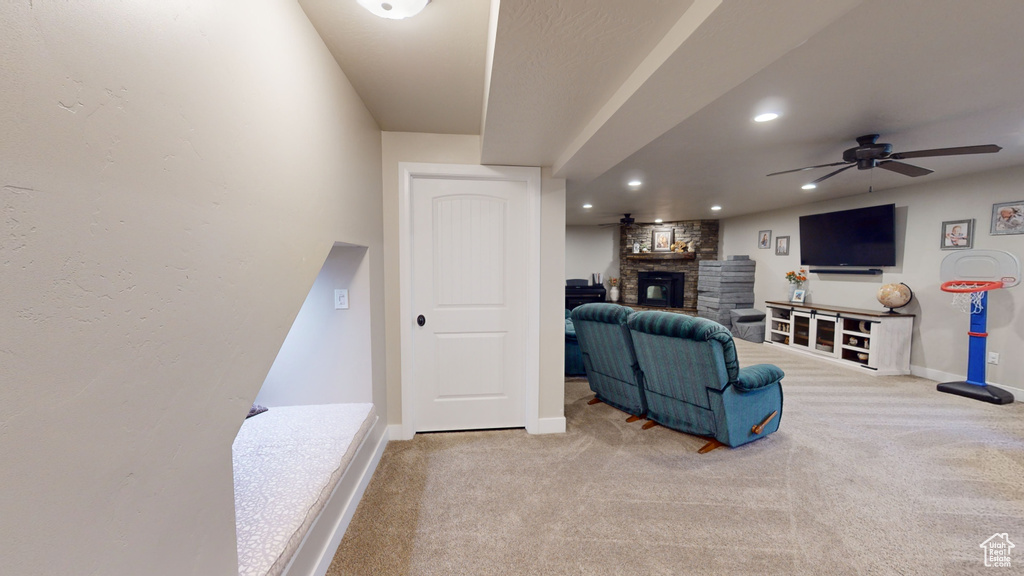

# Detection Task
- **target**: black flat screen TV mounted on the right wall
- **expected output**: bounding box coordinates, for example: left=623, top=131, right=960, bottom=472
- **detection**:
left=800, top=204, right=896, bottom=266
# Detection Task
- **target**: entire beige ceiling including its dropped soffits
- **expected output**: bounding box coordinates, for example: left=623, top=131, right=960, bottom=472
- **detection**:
left=300, top=0, right=1024, bottom=224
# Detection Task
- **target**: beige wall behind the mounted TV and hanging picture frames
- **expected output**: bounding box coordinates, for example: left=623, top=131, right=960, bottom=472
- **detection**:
left=722, top=168, right=1024, bottom=388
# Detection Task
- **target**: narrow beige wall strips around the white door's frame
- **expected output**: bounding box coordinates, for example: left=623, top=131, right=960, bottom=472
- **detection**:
left=382, top=132, right=565, bottom=424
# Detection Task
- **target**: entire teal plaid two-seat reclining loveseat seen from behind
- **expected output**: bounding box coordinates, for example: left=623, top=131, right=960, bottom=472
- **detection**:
left=572, top=303, right=784, bottom=453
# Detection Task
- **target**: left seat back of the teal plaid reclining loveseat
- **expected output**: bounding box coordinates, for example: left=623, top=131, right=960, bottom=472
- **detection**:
left=571, top=303, right=647, bottom=421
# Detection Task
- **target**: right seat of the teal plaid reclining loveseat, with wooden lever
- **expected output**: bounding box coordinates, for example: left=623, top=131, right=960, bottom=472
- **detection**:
left=628, top=312, right=784, bottom=453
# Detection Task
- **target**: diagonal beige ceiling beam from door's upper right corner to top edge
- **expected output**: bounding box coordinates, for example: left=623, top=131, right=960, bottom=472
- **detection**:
left=553, top=0, right=862, bottom=184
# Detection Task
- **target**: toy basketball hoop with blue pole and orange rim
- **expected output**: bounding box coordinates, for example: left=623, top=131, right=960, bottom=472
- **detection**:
left=937, top=250, right=1021, bottom=404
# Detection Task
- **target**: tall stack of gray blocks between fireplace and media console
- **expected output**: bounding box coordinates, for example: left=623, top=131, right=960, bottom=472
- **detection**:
left=697, top=256, right=757, bottom=327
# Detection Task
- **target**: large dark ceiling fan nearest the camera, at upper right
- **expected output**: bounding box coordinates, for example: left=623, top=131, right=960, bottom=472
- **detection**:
left=768, top=134, right=1002, bottom=186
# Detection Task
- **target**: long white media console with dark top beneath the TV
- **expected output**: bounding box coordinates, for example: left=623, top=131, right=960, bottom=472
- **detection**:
left=765, top=301, right=913, bottom=376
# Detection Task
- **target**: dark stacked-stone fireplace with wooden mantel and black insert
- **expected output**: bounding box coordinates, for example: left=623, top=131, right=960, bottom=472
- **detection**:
left=618, top=220, right=719, bottom=310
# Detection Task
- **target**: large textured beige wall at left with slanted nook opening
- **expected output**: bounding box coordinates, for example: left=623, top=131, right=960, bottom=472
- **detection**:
left=0, top=0, right=386, bottom=576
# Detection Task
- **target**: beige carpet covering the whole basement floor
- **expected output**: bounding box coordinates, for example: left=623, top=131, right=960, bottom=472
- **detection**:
left=329, top=341, right=1024, bottom=576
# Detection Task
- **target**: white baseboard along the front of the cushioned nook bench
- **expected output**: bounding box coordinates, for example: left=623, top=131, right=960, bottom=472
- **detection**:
left=284, top=416, right=390, bottom=576
